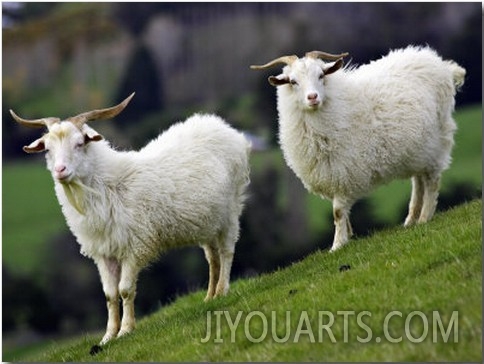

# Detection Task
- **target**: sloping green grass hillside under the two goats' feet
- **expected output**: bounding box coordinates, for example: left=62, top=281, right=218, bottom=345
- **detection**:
left=11, top=201, right=482, bottom=362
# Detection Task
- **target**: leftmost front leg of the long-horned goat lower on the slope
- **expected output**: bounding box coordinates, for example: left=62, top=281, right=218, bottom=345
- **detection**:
left=96, top=258, right=121, bottom=345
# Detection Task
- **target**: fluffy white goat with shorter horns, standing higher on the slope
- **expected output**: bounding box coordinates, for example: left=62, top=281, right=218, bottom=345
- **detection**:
left=251, top=46, right=465, bottom=251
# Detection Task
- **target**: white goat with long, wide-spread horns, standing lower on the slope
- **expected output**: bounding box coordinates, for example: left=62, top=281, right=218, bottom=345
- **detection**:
left=10, top=95, right=250, bottom=345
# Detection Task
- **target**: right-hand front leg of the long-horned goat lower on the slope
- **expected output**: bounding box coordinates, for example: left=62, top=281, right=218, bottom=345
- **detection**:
left=118, top=261, right=139, bottom=337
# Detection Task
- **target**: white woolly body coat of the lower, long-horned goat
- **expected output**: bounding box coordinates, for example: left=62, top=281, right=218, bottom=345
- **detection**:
left=55, top=115, right=250, bottom=267
